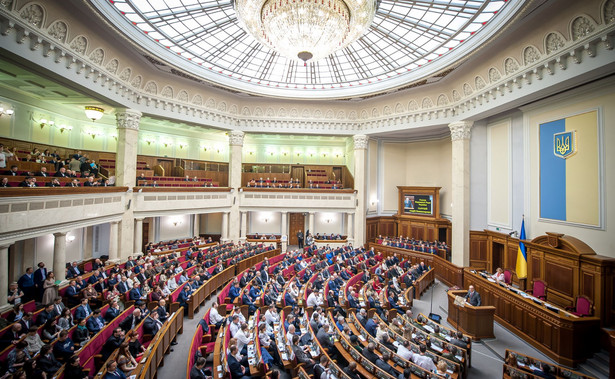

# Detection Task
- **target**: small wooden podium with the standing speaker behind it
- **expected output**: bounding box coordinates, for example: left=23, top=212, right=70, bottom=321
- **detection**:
left=447, top=291, right=495, bottom=340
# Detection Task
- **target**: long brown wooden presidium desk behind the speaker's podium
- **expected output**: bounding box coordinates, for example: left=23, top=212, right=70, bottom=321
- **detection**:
left=464, top=268, right=600, bottom=367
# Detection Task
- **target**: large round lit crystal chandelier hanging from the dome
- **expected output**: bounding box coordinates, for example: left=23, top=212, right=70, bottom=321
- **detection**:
left=235, top=0, right=376, bottom=62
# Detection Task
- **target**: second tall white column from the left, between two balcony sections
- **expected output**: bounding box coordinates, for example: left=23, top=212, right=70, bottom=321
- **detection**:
left=228, top=130, right=245, bottom=241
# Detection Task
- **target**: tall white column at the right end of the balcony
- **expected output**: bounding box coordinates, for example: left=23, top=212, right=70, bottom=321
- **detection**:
left=353, top=134, right=369, bottom=247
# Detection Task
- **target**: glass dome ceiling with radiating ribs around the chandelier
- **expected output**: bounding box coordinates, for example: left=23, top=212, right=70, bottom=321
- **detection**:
left=91, top=0, right=524, bottom=99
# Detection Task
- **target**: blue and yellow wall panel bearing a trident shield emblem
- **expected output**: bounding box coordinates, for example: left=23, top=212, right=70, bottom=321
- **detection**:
left=539, top=111, right=600, bottom=226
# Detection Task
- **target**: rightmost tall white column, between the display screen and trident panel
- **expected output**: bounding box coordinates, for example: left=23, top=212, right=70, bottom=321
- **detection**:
left=448, top=121, right=473, bottom=267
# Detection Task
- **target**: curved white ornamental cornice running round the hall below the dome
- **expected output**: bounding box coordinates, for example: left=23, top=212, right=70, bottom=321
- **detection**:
left=0, top=0, right=615, bottom=135
